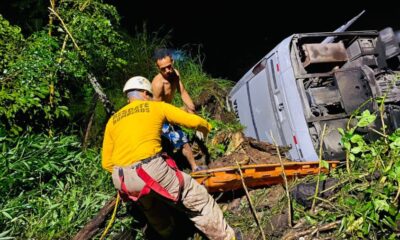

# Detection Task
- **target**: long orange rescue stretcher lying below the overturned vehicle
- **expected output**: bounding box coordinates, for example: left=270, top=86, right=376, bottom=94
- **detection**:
left=191, top=161, right=340, bottom=192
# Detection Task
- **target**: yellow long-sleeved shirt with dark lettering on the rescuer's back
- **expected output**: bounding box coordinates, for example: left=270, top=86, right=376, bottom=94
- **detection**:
left=101, top=100, right=211, bottom=172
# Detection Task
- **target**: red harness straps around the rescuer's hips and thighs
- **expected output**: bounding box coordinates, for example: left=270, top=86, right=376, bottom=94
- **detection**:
left=119, top=155, right=184, bottom=202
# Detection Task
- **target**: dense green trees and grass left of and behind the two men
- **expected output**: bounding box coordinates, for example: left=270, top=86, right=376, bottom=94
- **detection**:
left=0, top=0, right=236, bottom=239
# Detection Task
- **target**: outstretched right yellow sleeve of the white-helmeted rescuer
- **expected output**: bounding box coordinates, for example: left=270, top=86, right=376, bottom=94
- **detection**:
left=162, top=102, right=211, bottom=133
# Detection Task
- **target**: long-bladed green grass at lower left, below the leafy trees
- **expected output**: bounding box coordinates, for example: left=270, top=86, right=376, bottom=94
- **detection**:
left=0, top=135, right=115, bottom=239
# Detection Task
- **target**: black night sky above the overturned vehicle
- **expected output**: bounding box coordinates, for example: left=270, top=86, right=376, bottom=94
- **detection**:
left=107, top=0, right=400, bottom=81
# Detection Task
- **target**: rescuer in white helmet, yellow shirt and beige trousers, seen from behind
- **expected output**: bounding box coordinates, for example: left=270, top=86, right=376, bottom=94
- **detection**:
left=102, top=76, right=235, bottom=240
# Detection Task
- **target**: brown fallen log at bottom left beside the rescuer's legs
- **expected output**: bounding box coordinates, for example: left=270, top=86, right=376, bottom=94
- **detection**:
left=73, top=197, right=116, bottom=240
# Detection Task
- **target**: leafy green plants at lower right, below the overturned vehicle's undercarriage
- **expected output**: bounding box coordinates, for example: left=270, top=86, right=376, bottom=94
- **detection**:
left=297, top=106, right=400, bottom=239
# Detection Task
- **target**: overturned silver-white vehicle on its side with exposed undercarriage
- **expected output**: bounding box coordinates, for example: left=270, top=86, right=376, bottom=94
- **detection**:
left=228, top=28, right=400, bottom=161
